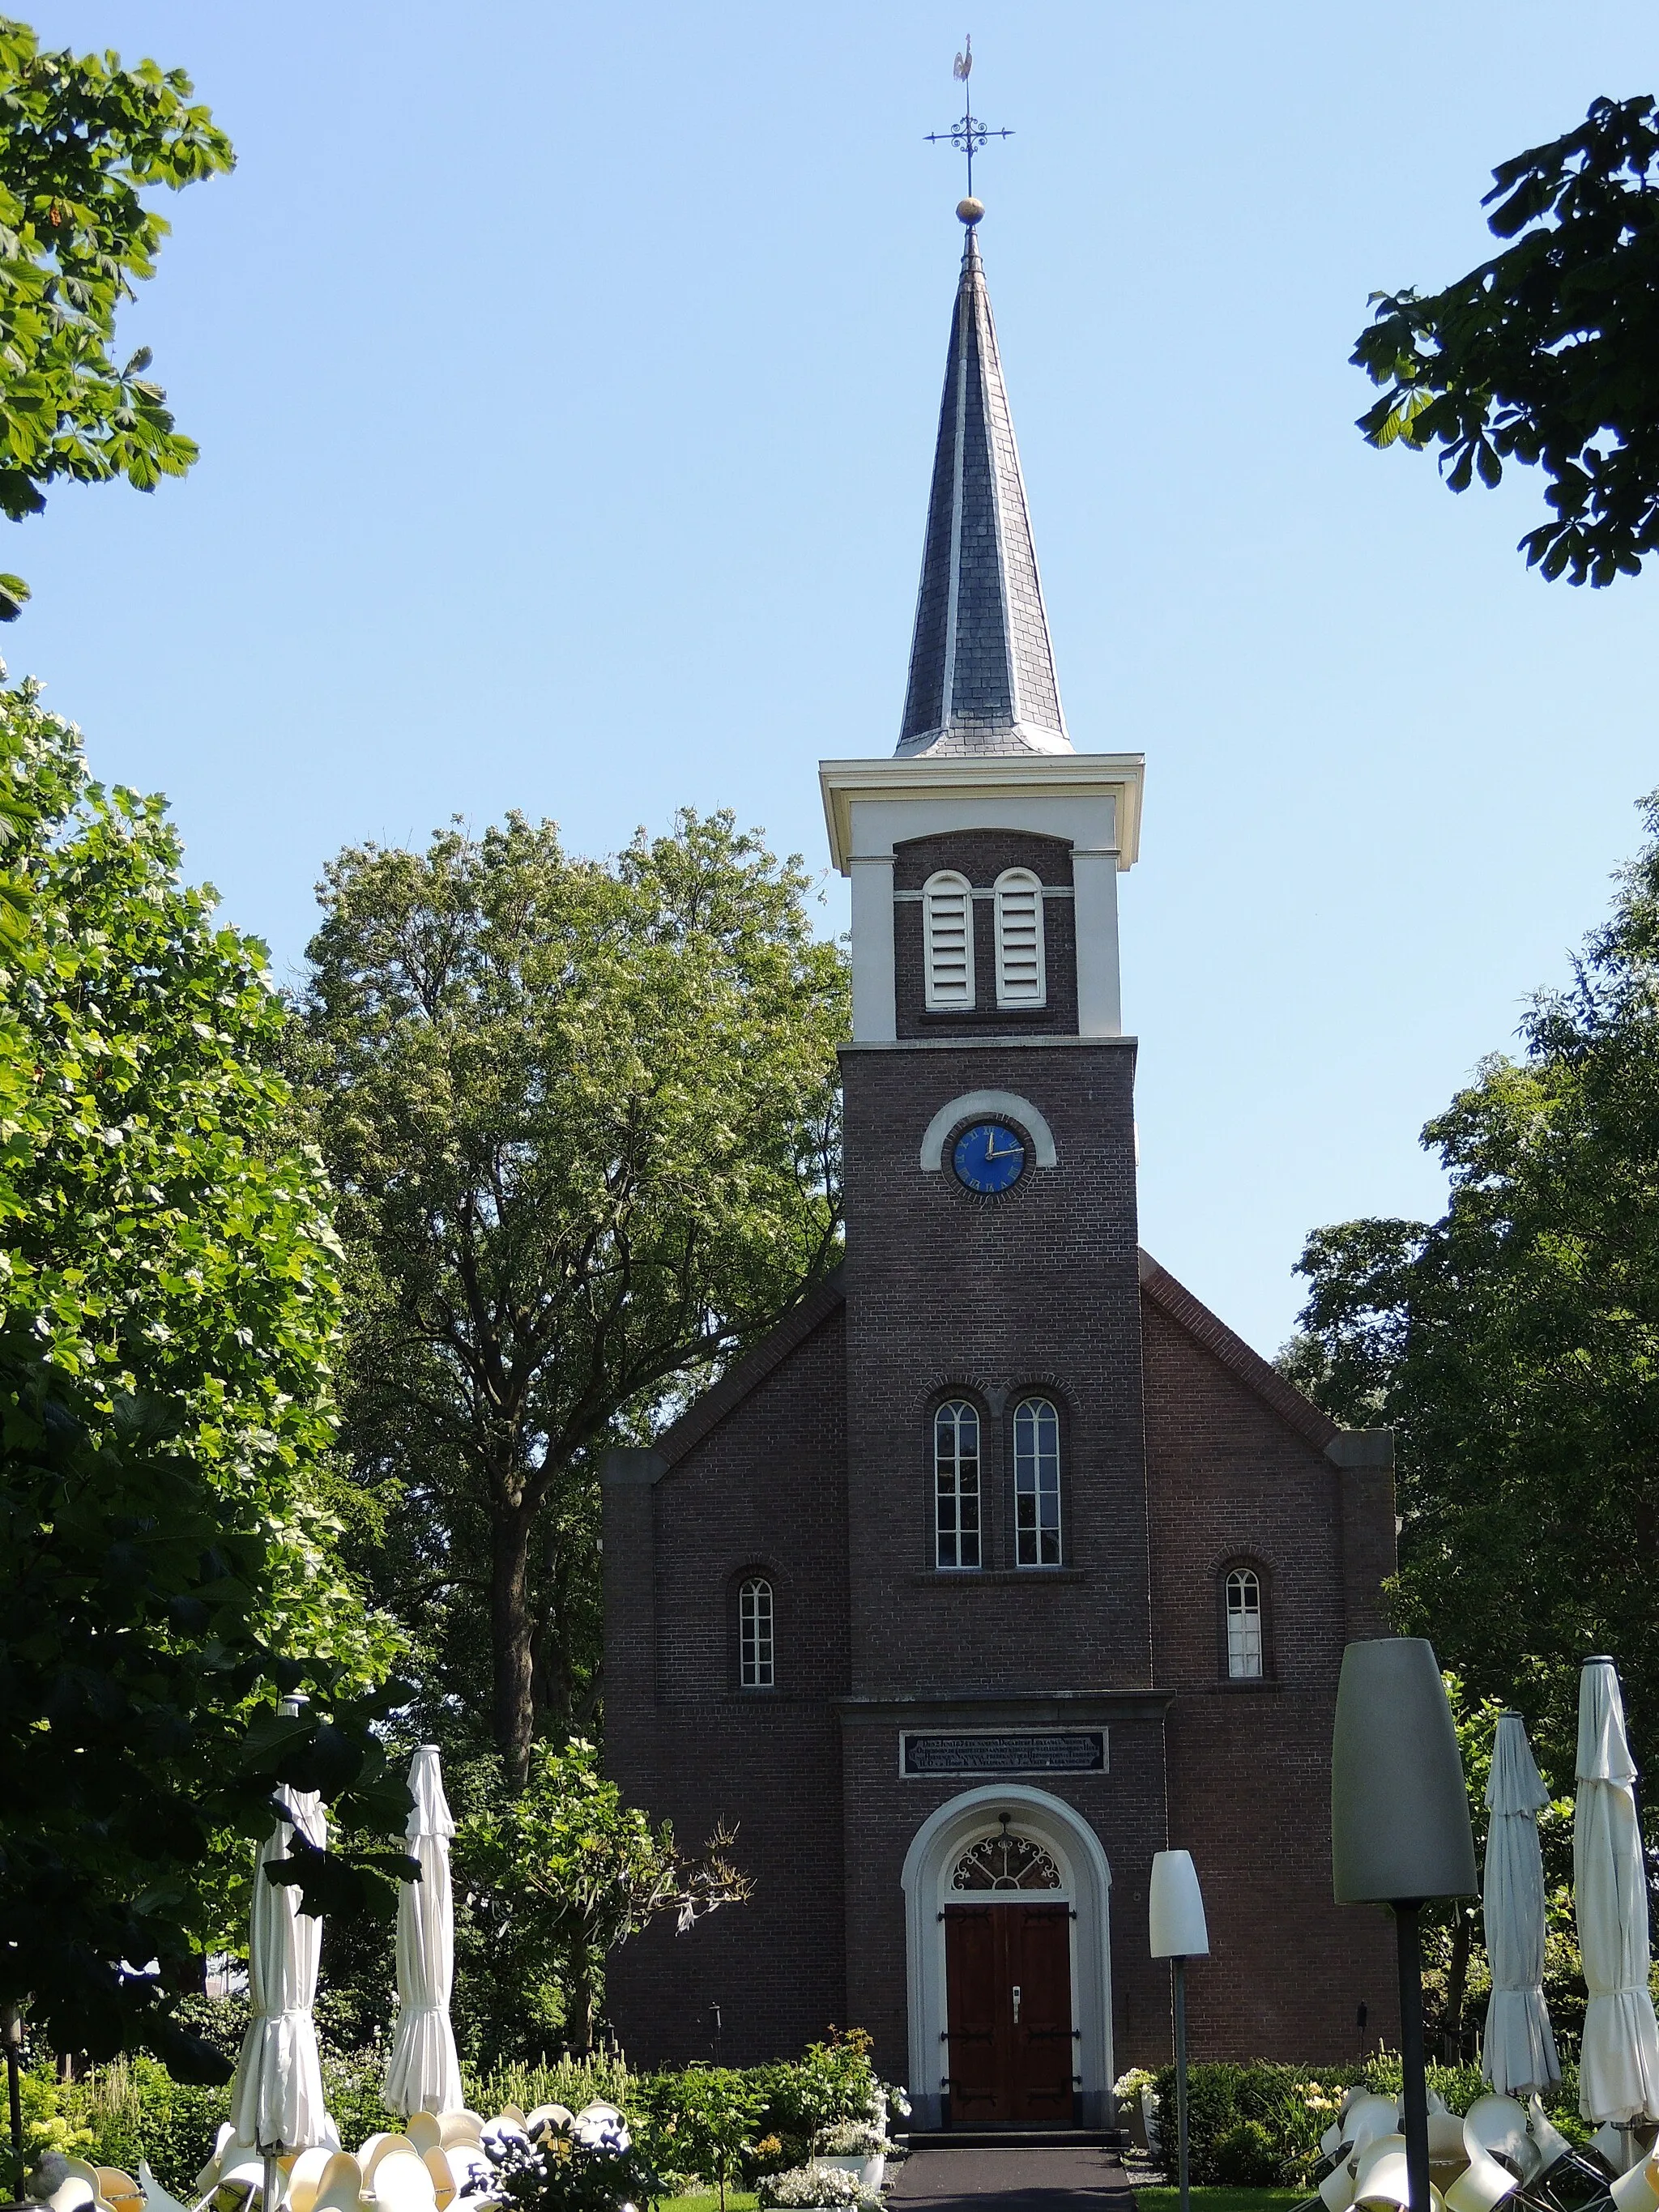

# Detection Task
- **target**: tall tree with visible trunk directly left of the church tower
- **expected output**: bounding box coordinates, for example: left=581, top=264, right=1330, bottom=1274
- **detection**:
left=292, top=814, right=847, bottom=1776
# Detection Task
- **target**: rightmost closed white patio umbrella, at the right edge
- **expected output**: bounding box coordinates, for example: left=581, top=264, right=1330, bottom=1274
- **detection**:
left=1573, top=1659, right=1659, bottom=2125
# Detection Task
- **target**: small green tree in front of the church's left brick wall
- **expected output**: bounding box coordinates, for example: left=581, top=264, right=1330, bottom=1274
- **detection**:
left=456, top=1737, right=752, bottom=2057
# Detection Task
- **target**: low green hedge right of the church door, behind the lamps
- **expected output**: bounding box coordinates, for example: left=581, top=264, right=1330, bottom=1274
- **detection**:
left=1154, top=2051, right=1584, bottom=2190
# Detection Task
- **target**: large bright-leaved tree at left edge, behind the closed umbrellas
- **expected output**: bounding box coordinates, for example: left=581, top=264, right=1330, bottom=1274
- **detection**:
left=0, top=686, right=407, bottom=2066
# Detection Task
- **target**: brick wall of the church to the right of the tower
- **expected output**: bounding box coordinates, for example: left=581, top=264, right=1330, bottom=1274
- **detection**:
left=1144, top=1298, right=1398, bottom=2061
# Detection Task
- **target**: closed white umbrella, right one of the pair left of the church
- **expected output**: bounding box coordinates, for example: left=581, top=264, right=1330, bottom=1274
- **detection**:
left=385, top=1743, right=467, bottom=2117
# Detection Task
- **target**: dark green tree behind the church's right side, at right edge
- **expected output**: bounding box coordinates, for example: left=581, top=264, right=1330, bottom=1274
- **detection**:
left=1290, top=796, right=1659, bottom=1788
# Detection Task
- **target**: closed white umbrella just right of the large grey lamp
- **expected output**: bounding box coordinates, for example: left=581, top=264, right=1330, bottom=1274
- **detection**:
left=1480, top=1712, right=1562, bottom=2097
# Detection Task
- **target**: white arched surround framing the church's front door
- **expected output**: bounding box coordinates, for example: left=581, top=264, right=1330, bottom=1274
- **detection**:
left=900, top=1780, right=1113, bottom=2128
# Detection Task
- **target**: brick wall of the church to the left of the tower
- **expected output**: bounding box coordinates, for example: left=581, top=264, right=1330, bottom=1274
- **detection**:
left=603, top=1305, right=847, bottom=2066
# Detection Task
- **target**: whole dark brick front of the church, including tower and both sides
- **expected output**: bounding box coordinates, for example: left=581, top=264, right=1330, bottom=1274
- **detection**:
left=603, top=829, right=1396, bottom=2119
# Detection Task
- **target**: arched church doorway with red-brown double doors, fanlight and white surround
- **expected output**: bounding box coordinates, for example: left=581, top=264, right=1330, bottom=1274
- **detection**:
left=902, top=1783, right=1113, bottom=2128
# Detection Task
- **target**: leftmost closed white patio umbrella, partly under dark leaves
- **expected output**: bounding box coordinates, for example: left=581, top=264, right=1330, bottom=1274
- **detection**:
left=221, top=1707, right=341, bottom=2208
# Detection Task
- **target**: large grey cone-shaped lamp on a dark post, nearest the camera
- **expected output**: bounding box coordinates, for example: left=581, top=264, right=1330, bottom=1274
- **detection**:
left=1332, top=1637, right=1478, bottom=2212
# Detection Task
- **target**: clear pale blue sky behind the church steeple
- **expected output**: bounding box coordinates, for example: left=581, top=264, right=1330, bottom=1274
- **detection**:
left=19, top=0, right=1659, bottom=1352
